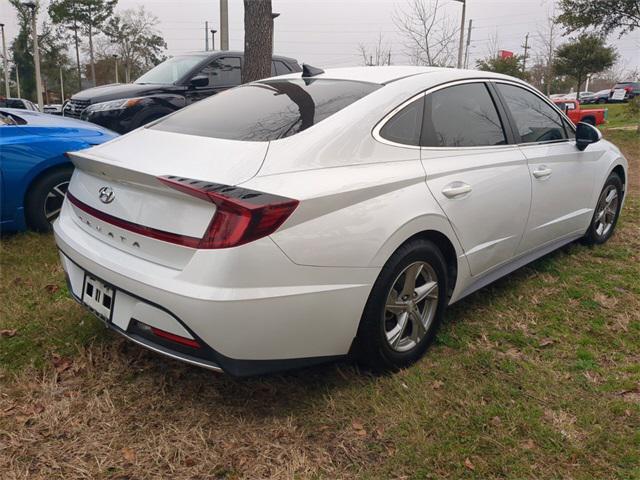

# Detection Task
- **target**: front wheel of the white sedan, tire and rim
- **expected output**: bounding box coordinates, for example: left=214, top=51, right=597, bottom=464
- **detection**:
left=583, top=173, right=624, bottom=245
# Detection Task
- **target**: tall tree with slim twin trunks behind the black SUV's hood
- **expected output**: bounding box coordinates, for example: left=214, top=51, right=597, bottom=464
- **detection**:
left=49, top=0, right=118, bottom=85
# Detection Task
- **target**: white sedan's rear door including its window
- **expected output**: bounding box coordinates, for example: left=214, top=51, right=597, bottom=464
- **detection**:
left=420, top=80, right=531, bottom=275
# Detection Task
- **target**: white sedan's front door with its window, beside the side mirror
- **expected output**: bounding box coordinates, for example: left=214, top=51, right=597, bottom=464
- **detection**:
left=495, top=82, right=601, bottom=253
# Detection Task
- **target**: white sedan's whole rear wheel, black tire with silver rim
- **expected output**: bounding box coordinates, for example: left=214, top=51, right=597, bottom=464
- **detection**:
left=355, top=239, right=448, bottom=371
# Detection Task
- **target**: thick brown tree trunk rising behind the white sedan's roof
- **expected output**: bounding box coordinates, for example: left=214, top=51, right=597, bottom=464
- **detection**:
left=242, top=0, right=273, bottom=83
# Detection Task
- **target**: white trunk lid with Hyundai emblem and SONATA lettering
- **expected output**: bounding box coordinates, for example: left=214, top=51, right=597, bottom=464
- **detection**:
left=68, top=129, right=268, bottom=268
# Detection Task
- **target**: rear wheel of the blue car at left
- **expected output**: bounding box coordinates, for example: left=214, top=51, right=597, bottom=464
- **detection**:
left=24, top=166, right=73, bottom=232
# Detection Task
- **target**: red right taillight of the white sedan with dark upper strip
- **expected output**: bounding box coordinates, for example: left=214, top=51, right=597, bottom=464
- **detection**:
left=158, top=176, right=299, bottom=249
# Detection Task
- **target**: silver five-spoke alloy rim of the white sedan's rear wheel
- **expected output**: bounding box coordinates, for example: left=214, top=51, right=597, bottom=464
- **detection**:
left=384, top=262, right=438, bottom=352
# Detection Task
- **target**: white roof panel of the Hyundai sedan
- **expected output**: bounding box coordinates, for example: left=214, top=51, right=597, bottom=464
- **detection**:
left=279, top=65, right=521, bottom=84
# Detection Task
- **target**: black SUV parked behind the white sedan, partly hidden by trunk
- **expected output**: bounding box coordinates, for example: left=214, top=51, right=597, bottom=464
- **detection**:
left=63, top=51, right=302, bottom=133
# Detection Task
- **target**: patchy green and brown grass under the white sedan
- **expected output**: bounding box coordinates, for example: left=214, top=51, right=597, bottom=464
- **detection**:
left=0, top=131, right=640, bottom=480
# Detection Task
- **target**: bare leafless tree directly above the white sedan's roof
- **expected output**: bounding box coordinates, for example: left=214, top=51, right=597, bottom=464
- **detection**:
left=393, top=0, right=459, bottom=67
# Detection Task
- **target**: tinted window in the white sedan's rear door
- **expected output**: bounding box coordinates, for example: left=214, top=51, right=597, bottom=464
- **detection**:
left=422, top=83, right=506, bottom=147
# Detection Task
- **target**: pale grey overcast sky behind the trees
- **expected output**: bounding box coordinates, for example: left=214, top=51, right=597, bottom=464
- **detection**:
left=0, top=0, right=640, bottom=69
